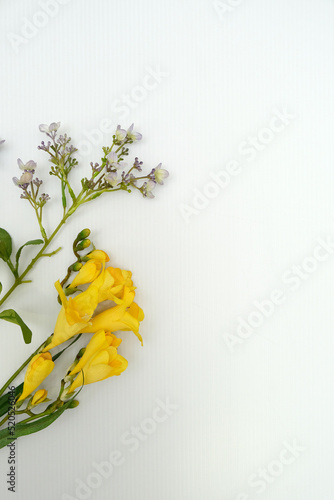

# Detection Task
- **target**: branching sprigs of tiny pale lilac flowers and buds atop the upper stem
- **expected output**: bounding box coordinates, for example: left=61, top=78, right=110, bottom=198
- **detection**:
left=9, top=122, right=169, bottom=241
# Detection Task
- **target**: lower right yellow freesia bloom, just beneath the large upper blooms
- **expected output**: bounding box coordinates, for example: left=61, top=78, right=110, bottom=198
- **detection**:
left=69, top=330, right=128, bottom=393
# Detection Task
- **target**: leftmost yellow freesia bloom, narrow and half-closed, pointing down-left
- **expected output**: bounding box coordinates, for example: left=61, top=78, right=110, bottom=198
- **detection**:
left=18, top=352, right=55, bottom=401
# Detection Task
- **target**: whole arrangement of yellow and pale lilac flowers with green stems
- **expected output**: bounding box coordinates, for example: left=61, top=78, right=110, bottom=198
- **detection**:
left=0, top=123, right=168, bottom=448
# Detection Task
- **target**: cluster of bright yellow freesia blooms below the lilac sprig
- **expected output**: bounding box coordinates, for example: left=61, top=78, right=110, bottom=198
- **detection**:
left=17, top=240, right=144, bottom=411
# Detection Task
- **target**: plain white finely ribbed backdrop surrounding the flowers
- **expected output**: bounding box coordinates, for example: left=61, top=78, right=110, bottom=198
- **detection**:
left=0, top=0, right=334, bottom=500
